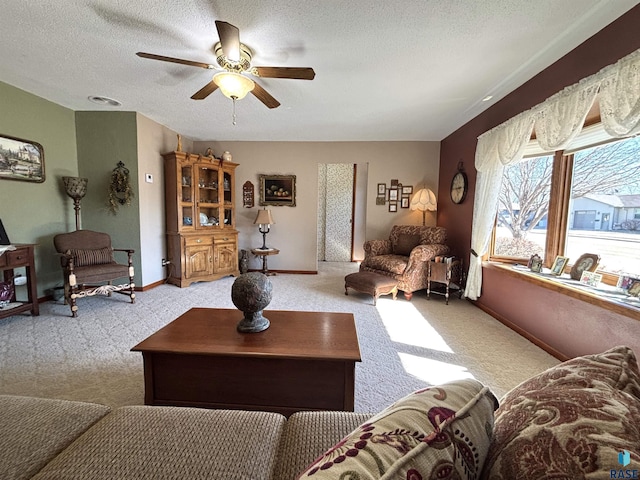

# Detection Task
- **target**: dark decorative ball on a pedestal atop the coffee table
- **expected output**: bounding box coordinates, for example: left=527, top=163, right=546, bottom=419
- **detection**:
left=231, top=272, right=273, bottom=333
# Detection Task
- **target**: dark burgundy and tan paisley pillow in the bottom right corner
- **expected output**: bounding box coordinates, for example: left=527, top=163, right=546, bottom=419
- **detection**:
left=482, top=347, right=640, bottom=480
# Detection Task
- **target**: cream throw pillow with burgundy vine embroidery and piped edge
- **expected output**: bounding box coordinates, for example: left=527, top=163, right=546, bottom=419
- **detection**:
left=298, top=379, right=497, bottom=480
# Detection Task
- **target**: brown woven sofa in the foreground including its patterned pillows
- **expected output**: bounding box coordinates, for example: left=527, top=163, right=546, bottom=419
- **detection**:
left=0, top=347, right=640, bottom=480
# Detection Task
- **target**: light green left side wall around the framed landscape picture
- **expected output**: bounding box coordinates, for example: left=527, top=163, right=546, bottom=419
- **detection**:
left=0, top=82, right=78, bottom=296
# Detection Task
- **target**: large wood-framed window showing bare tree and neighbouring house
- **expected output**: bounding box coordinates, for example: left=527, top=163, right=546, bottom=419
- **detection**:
left=491, top=126, right=640, bottom=282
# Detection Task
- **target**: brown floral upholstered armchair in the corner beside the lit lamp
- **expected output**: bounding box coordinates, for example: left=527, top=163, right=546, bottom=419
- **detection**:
left=360, top=225, right=449, bottom=300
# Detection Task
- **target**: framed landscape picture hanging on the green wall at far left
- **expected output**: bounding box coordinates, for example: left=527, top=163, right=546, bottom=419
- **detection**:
left=0, top=135, right=44, bottom=183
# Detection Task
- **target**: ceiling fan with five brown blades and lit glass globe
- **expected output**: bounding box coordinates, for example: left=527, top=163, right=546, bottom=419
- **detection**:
left=136, top=20, right=316, bottom=108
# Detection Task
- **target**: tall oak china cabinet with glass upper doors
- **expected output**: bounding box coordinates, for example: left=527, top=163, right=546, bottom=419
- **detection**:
left=163, top=152, right=240, bottom=287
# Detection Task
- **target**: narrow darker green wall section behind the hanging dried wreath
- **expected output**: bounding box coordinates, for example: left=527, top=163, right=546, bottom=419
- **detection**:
left=75, top=112, right=142, bottom=286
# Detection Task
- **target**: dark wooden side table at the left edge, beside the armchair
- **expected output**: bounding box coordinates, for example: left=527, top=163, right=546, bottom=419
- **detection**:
left=0, top=244, right=40, bottom=318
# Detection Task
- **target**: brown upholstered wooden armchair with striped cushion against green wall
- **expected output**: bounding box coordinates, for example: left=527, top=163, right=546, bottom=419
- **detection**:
left=53, top=230, right=136, bottom=317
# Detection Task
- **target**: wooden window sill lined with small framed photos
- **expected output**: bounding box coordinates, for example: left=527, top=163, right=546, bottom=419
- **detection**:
left=482, top=262, right=640, bottom=320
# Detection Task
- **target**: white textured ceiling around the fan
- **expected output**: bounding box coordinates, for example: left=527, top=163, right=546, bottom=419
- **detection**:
left=0, top=0, right=638, bottom=141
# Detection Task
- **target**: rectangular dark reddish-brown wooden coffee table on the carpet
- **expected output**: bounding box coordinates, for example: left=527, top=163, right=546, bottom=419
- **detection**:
left=132, top=308, right=361, bottom=416
